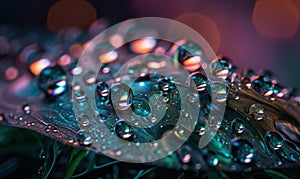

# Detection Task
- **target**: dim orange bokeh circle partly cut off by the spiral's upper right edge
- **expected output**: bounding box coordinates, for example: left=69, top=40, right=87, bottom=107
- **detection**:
left=175, top=12, right=220, bottom=52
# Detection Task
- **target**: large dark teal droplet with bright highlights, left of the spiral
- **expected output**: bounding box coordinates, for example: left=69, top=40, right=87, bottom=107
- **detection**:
left=38, top=66, right=67, bottom=96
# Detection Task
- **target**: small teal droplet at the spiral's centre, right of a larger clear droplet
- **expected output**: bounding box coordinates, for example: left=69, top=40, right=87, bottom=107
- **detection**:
left=131, top=97, right=151, bottom=116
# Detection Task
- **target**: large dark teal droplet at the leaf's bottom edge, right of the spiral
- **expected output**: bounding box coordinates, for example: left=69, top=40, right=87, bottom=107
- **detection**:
left=231, top=138, right=254, bottom=163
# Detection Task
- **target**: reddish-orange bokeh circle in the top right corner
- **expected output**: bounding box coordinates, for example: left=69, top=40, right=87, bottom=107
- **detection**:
left=252, top=0, right=300, bottom=39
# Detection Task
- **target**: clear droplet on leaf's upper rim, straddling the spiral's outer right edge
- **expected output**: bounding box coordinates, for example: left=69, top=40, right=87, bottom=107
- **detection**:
left=211, top=56, right=232, bottom=80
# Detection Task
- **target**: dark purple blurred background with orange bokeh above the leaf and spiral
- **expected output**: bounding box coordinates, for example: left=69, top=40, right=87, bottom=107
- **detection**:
left=0, top=0, right=300, bottom=89
